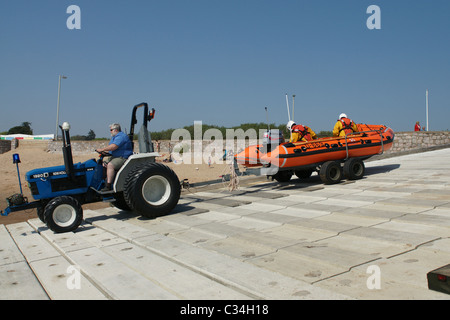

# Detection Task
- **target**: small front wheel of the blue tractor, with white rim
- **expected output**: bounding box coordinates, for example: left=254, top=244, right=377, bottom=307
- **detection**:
left=43, top=196, right=83, bottom=233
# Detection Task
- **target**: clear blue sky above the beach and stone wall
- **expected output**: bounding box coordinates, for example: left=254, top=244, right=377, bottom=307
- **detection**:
left=0, top=0, right=450, bottom=137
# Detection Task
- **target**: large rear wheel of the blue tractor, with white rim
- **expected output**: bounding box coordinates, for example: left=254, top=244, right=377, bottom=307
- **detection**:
left=123, top=163, right=181, bottom=218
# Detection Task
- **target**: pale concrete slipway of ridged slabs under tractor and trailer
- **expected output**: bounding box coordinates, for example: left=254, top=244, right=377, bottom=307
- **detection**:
left=0, top=149, right=450, bottom=300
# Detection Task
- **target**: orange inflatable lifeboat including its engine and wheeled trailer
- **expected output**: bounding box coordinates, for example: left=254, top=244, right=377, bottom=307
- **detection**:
left=235, top=124, right=394, bottom=184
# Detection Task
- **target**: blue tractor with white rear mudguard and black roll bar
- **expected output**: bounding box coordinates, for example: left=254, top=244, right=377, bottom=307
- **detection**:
left=0, top=103, right=181, bottom=233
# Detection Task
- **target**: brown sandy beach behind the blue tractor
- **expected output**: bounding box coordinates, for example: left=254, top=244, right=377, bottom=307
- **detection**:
left=0, top=143, right=243, bottom=225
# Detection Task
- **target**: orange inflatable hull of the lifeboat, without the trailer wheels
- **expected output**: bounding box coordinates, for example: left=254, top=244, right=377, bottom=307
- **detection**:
left=235, top=124, right=394, bottom=171
